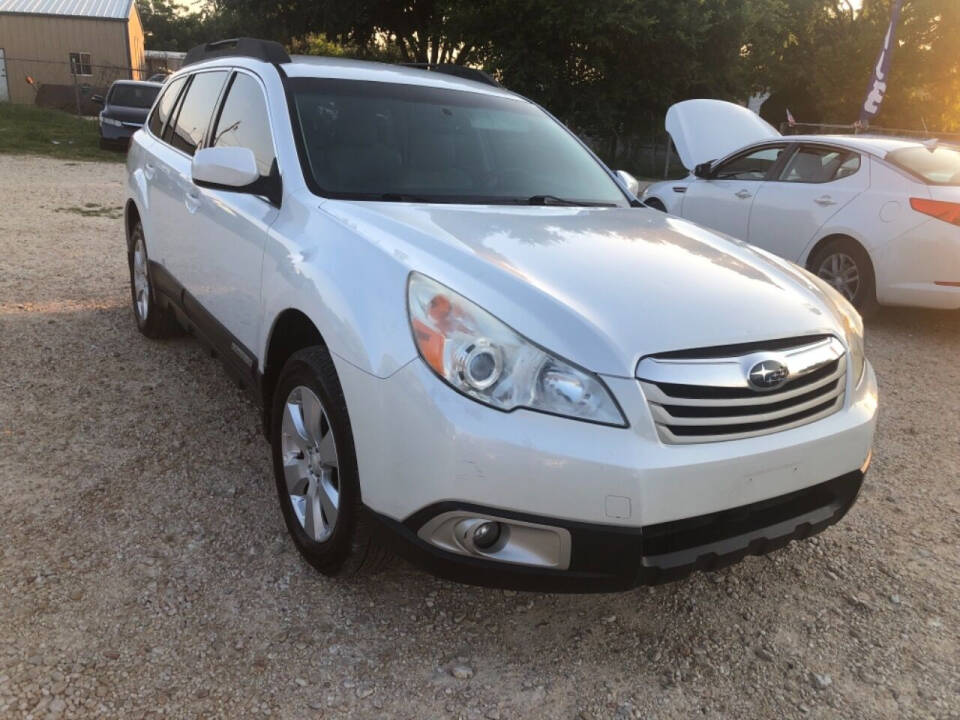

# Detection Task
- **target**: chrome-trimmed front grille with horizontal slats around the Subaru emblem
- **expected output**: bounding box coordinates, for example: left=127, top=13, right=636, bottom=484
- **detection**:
left=637, top=336, right=846, bottom=444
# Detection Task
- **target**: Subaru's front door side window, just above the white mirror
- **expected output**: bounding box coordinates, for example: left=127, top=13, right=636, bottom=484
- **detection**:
left=213, top=73, right=274, bottom=175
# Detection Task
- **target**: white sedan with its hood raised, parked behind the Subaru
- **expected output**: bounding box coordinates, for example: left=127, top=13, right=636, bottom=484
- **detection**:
left=642, top=100, right=960, bottom=313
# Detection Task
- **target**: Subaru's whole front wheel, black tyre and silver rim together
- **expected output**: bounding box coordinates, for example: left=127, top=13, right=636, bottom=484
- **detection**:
left=271, top=347, right=391, bottom=575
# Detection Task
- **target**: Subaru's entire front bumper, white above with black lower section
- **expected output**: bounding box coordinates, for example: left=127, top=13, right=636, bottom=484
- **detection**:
left=335, top=358, right=877, bottom=591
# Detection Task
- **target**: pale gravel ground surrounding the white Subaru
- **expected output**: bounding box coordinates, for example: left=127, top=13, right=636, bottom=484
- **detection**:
left=0, top=156, right=960, bottom=719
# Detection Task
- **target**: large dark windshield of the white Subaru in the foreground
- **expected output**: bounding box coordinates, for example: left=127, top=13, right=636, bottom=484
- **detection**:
left=290, top=78, right=627, bottom=206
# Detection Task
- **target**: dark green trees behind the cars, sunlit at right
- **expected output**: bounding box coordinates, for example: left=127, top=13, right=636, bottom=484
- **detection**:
left=139, top=0, right=960, bottom=137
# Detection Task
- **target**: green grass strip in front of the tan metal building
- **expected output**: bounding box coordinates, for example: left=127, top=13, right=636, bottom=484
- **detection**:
left=0, top=103, right=126, bottom=162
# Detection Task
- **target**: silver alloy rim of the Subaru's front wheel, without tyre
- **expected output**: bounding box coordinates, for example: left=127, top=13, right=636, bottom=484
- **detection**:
left=281, top=385, right=340, bottom=542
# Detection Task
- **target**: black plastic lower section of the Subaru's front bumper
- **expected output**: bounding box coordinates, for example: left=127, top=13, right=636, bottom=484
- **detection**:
left=372, top=470, right=863, bottom=593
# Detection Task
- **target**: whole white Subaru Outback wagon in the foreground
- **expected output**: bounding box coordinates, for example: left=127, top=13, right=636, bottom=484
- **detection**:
left=126, top=39, right=877, bottom=591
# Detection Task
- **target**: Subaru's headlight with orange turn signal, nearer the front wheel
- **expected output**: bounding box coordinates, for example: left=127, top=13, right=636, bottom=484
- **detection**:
left=407, top=273, right=627, bottom=427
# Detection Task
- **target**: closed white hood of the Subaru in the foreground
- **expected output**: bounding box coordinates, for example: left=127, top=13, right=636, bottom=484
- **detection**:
left=323, top=201, right=842, bottom=377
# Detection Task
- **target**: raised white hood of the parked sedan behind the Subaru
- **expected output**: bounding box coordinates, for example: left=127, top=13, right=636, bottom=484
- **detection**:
left=666, top=100, right=780, bottom=170
